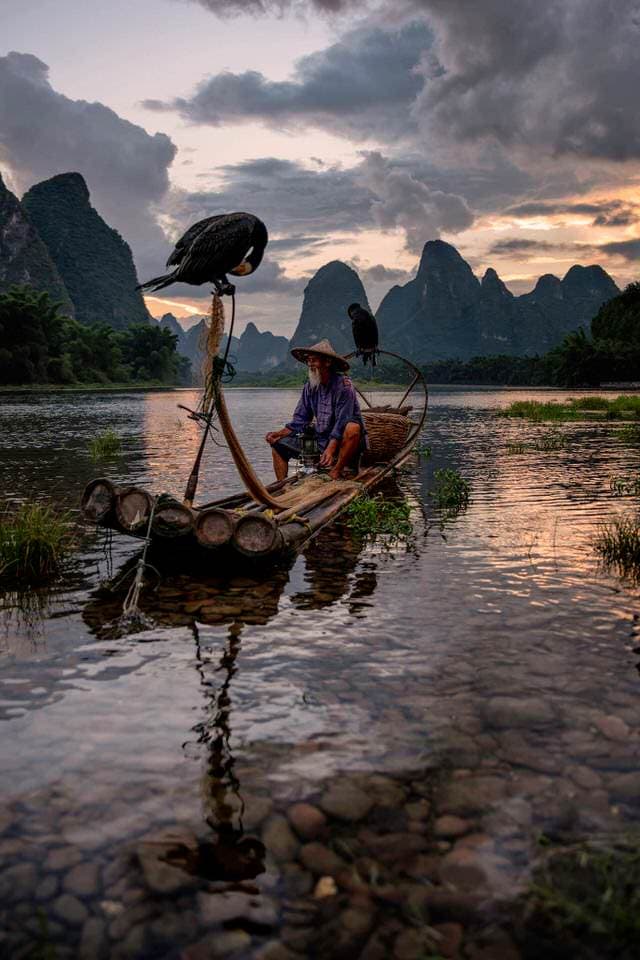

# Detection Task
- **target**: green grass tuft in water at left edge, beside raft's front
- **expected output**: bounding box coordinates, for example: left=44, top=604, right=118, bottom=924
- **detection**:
left=0, top=503, right=72, bottom=583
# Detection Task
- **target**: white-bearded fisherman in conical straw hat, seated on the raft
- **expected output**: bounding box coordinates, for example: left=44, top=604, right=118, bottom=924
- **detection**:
left=265, top=340, right=367, bottom=480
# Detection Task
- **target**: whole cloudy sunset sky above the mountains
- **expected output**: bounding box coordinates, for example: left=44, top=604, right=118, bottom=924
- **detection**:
left=0, top=0, right=640, bottom=335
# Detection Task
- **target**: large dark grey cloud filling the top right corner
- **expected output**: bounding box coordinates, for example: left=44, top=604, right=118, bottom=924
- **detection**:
left=415, top=0, right=640, bottom=161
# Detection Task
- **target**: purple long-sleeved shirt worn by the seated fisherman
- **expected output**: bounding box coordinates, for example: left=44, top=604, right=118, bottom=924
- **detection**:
left=285, top=373, right=367, bottom=450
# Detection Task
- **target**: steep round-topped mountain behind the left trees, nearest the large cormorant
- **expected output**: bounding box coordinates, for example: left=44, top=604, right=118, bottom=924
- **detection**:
left=22, top=173, right=150, bottom=330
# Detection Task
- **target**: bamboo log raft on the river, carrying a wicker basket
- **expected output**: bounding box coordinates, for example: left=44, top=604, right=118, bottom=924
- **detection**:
left=81, top=350, right=427, bottom=562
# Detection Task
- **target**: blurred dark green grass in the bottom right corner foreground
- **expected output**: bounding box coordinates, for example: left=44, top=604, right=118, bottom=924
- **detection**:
left=526, top=837, right=640, bottom=958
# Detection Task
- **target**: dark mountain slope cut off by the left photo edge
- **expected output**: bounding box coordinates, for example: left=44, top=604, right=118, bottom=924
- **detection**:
left=0, top=169, right=74, bottom=316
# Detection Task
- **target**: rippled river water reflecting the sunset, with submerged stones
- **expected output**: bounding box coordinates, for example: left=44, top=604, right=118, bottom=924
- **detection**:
left=0, top=388, right=640, bottom=960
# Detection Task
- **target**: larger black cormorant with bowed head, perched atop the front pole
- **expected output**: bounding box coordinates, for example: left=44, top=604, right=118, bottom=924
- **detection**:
left=136, top=213, right=269, bottom=294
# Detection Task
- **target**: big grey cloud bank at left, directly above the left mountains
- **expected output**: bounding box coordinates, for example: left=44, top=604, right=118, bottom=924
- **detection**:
left=0, top=53, right=176, bottom=280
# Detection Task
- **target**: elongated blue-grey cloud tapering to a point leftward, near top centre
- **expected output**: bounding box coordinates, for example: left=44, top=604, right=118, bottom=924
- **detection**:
left=144, top=23, right=431, bottom=139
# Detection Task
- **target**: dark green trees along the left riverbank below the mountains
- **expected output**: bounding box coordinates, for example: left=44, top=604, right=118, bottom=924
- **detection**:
left=0, top=286, right=191, bottom=385
